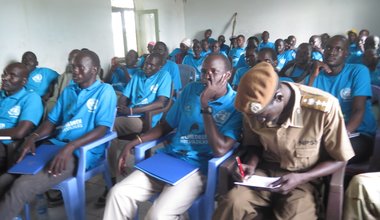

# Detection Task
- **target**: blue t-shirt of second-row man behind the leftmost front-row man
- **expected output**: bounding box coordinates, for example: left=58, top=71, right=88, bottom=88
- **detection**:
left=25, top=67, right=59, bottom=96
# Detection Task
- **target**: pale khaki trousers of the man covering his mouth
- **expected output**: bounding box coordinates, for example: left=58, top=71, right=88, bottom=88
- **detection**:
left=103, top=170, right=206, bottom=220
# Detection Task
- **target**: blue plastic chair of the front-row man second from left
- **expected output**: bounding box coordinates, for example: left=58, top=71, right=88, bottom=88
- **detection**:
left=24, top=131, right=117, bottom=220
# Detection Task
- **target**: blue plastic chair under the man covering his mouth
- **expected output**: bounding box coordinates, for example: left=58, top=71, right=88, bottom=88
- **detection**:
left=135, top=135, right=239, bottom=220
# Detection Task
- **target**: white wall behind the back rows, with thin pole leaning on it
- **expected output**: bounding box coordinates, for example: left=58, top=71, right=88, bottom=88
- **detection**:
left=183, top=0, right=380, bottom=44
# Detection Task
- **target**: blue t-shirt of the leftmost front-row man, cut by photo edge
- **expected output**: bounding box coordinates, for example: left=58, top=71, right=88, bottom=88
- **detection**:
left=0, top=88, right=44, bottom=144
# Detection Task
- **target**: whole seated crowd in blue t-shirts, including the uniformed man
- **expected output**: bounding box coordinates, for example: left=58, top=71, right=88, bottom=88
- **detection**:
left=0, top=29, right=380, bottom=220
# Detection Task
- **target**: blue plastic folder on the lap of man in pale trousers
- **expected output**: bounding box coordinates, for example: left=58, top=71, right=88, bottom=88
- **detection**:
left=135, top=153, right=199, bottom=186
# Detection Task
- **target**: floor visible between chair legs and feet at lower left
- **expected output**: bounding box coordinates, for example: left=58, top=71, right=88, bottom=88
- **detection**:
left=24, top=175, right=150, bottom=220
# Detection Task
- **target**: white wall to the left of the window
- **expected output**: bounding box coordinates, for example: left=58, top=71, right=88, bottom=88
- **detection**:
left=0, top=0, right=113, bottom=73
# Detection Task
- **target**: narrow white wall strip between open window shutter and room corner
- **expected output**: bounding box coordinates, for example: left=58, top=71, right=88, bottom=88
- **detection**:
left=135, top=0, right=186, bottom=50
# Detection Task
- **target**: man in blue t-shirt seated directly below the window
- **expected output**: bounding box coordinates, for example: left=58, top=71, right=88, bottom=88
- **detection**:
left=104, top=50, right=139, bottom=94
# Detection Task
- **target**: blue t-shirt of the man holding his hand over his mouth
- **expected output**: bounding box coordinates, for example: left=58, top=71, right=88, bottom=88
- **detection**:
left=160, top=82, right=242, bottom=173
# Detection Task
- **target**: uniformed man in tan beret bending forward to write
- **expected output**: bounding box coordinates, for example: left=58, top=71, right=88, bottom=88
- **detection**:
left=213, top=62, right=354, bottom=220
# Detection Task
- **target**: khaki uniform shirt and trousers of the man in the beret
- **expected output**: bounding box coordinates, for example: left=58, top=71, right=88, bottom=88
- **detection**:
left=214, top=83, right=354, bottom=220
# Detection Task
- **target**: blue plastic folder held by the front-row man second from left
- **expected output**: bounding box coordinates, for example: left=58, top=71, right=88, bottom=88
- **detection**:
left=8, top=145, right=62, bottom=175
